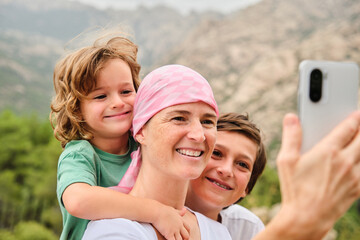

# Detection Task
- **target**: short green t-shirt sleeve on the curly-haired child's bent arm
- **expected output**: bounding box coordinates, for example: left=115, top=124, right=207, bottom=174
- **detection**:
left=57, top=151, right=97, bottom=205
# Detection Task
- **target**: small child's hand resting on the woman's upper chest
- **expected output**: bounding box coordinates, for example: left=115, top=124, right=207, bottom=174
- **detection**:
left=152, top=204, right=190, bottom=240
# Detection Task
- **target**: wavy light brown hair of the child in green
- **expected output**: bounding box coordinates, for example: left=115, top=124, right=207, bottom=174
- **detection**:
left=50, top=36, right=140, bottom=147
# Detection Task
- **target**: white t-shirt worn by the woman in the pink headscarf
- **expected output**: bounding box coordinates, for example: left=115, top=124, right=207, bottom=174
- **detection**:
left=82, top=209, right=231, bottom=240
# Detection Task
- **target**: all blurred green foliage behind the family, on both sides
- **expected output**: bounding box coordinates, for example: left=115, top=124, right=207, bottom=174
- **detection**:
left=0, top=111, right=360, bottom=240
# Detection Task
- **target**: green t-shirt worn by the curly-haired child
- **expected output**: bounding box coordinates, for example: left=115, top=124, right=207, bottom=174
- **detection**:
left=56, top=137, right=137, bottom=240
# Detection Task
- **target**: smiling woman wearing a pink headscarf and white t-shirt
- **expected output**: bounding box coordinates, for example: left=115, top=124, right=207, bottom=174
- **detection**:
left=83, top=65, right=231, bottom=240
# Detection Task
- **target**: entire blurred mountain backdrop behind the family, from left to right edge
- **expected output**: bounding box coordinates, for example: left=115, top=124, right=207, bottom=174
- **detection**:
left=0, top=0, right=360, bottom=161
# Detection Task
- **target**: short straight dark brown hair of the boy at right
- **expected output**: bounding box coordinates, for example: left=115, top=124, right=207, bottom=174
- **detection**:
left=217, top=113, right=267, bottom=203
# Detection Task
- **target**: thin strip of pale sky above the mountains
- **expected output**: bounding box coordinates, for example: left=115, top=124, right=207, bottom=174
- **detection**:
left=71, top=0, right=261, bottom=13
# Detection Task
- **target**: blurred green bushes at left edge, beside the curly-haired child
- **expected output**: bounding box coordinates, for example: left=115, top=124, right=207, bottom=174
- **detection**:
left=0, top=111, right=62, bottom=239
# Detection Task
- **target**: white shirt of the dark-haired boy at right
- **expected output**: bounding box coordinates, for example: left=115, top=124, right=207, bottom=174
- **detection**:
left=220, top=204, right=265, bottom=240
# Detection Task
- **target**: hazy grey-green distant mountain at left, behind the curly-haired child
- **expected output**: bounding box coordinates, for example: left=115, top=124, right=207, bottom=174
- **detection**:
left=0, top=0, right=222, bottom=116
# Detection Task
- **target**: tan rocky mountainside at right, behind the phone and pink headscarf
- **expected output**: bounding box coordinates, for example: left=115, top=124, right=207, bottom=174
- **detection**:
left=158, top=0, right=360, bottom=159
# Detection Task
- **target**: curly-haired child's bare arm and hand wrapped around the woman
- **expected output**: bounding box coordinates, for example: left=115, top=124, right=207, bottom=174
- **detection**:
left=62, top=183, right=189, bottom=239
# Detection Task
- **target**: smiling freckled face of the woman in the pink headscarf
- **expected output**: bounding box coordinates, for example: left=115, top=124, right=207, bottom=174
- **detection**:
left=136, top=102, right=216, bottom=181
